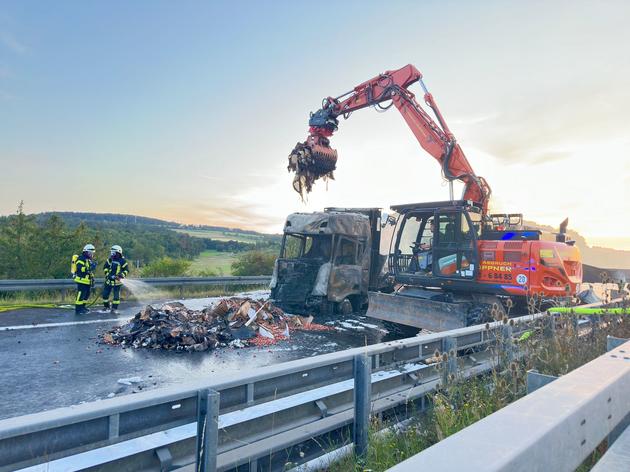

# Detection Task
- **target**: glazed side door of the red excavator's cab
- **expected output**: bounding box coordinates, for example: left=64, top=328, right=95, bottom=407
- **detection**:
left=433, top=210, right=478, bottom=279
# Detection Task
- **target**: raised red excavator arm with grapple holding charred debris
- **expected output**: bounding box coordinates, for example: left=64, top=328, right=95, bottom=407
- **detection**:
left=288, top=64, right=491, bottom=214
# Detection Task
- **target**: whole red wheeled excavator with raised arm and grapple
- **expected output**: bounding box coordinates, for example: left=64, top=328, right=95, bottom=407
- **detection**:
left=288, top=65, right=582, bottom=330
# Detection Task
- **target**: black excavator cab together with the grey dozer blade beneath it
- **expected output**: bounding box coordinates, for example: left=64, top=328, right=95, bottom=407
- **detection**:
left=367, top=200, right=483, bottom=331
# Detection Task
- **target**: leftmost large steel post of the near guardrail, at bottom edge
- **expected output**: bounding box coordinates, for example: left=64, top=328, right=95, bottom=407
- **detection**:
left=196, top=389, right=220, bottom=472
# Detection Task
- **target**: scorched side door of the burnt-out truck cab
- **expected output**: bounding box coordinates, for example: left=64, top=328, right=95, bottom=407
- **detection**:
left=328, top=236, right=362, bottom=302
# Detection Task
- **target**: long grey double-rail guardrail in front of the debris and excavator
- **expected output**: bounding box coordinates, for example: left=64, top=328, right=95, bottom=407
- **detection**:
left=0, top=308, right=545, bottom=471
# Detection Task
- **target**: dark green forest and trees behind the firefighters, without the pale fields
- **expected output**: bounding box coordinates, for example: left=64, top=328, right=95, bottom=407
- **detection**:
left=0, top=203, right=276, bottom=279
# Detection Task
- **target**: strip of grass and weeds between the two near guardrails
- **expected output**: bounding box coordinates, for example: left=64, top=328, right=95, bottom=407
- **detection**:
left=327, top=314, right=630, bottom=472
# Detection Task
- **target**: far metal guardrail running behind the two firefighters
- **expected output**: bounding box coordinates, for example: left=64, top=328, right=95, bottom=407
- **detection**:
left=0, top=275, right=271, bottom=293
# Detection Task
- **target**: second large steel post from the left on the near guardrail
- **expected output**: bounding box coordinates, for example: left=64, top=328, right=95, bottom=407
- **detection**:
left=353, top=353, right=372, bottom=457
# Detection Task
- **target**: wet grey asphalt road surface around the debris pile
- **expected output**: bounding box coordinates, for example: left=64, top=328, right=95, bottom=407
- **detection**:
left=0, top=299, right=416, bottom=419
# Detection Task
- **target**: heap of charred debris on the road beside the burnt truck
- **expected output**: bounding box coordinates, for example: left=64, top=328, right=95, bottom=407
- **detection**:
left=102, top=297, right=331, bottom=351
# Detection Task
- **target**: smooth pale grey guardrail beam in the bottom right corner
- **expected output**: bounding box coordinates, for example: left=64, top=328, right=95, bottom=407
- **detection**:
left=389, top=342, right=630, bottom=472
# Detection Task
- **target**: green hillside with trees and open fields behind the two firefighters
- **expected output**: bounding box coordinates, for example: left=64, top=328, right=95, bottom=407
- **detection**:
left=0, top=203, right=280, bottom=279
